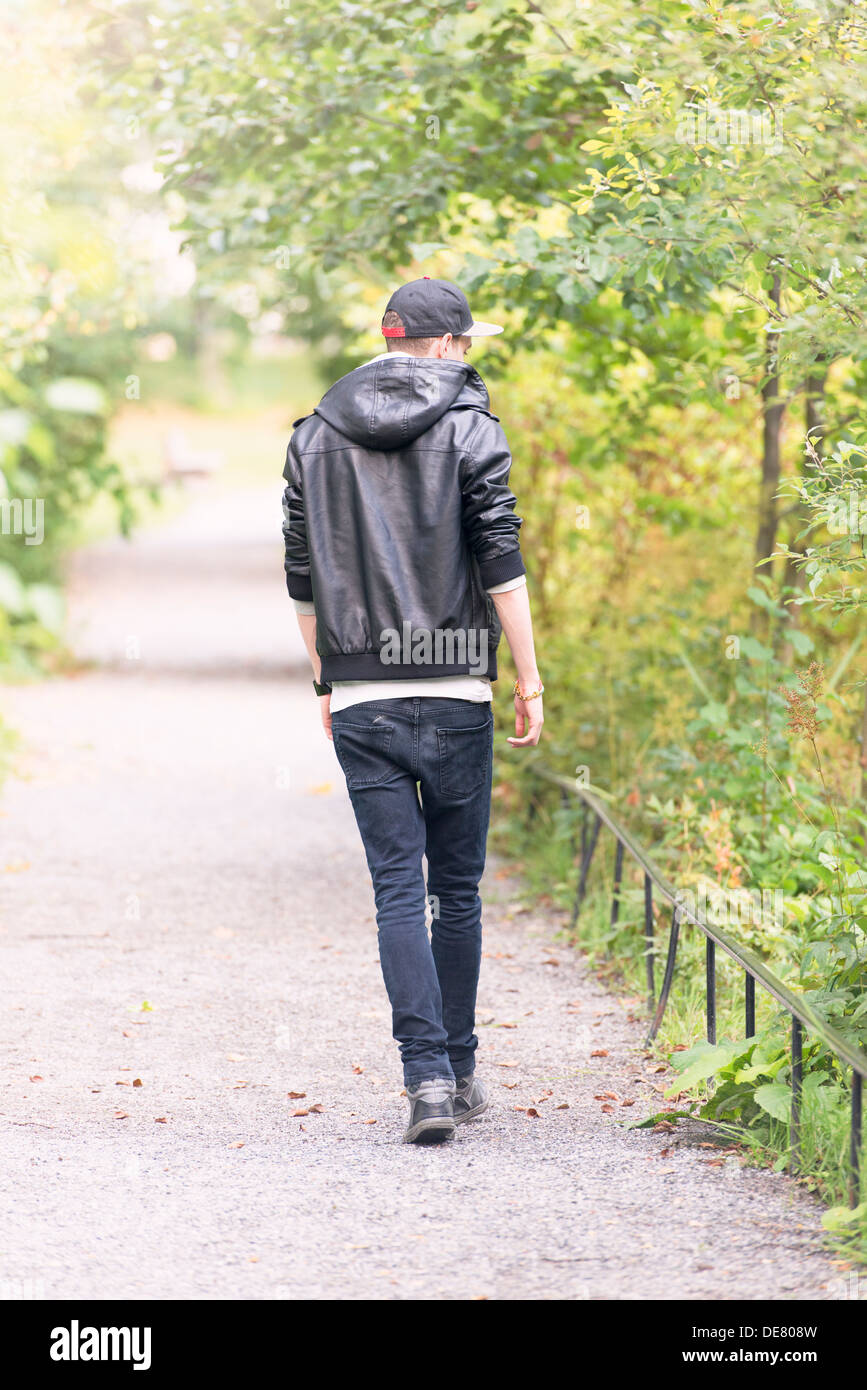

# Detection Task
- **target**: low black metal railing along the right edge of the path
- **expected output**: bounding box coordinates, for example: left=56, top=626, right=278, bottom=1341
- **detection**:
left=532, top=763, right=867, bottom=1207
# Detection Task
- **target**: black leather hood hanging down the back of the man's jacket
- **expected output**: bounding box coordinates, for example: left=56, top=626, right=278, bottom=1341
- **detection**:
left=314, top=354, right=489, bottom=449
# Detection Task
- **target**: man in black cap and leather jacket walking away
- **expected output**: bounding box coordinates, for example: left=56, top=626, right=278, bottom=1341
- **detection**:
left=283, top=275, right=542, bottom=1143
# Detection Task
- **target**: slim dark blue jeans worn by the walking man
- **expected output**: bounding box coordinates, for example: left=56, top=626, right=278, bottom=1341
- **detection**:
left=332, top=698, right=493, bottom=1086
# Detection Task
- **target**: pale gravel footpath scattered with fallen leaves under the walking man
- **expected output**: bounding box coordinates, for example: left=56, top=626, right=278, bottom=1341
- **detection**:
left=0, top=488, right=841, bottom=1300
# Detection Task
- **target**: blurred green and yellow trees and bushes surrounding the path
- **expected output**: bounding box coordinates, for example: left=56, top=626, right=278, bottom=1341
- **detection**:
left=0, top=0, right=867, bottom=1239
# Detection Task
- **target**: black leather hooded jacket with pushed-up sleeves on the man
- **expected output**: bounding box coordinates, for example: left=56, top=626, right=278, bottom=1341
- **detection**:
left=283, top=356, right=524, bottom=682
